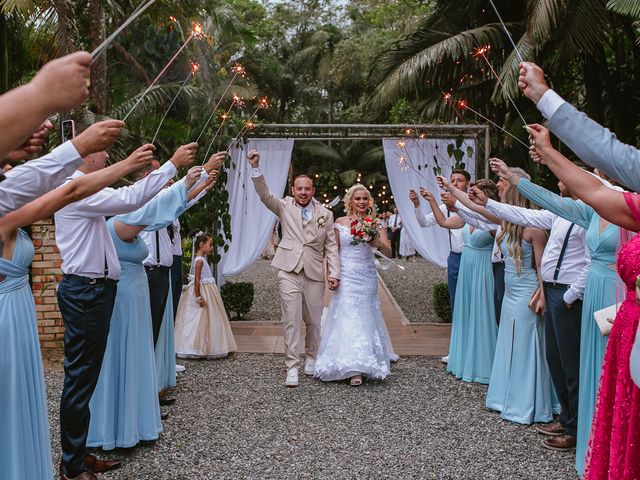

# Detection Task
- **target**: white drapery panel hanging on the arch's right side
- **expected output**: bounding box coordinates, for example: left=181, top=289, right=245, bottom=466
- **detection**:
left=382, top=138, right=476, bottom=267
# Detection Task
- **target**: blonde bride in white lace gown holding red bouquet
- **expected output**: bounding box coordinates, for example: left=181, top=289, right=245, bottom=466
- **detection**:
left=314, top=185, right=398, bottom=386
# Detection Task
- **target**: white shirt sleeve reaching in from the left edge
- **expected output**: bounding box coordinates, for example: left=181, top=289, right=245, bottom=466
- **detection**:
left=0, top=141, right=82, bottom=217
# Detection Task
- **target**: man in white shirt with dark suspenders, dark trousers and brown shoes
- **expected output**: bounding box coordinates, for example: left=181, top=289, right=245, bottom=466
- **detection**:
left=479, top=182, right=591, bottom=451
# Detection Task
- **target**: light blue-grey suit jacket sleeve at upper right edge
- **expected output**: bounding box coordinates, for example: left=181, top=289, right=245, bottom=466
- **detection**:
left=549, top=102, right=640, bottom=192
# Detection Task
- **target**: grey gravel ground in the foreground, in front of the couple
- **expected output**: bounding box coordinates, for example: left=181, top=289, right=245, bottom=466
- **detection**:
left=45, top=354, right=577, bottom=480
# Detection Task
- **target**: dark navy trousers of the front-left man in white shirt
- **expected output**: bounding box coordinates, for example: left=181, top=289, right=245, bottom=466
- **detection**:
left=58, top=275, right=117, bottom=477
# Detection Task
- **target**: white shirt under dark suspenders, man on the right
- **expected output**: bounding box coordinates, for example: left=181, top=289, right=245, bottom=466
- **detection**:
left=487, top=200, right=591, bottom=305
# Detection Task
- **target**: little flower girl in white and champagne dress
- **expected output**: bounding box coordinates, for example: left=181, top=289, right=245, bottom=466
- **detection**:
left=175, top=232, right=237, bottom=359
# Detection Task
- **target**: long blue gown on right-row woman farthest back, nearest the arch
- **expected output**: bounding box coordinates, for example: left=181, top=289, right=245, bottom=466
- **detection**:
left=447, top=225, right=498, bottom=383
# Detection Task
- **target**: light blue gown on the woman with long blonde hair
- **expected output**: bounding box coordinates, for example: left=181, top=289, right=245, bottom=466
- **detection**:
left=486, top=237, right=559, bottom=425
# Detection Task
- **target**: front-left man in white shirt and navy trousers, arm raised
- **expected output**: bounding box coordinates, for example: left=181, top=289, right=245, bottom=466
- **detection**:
left=55, top=136, right=195, bottom=480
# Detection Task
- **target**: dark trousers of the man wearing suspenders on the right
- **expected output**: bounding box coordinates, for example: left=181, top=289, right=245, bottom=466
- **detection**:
left=544, top=284, right=582, bottom=437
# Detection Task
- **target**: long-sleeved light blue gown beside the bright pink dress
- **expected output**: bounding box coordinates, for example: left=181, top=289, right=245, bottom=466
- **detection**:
left=518, top=180, right=621, bottom=475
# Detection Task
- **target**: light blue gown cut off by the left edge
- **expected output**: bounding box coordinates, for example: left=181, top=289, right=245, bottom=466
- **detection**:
left=0, top=230, right=53, bottom=480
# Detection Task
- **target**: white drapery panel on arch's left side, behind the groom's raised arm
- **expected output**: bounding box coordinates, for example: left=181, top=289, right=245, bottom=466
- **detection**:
left=218, top=138, right=293, bottom=285
